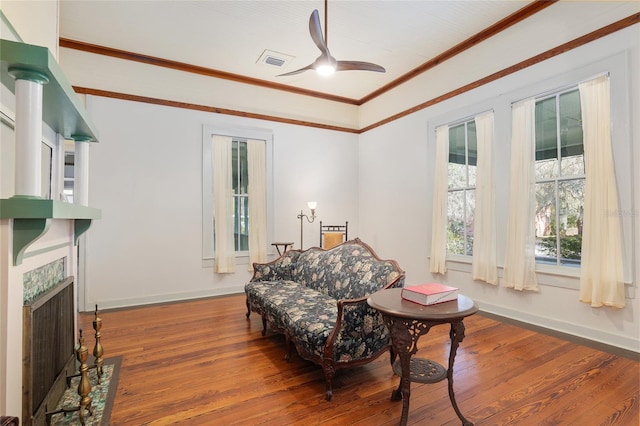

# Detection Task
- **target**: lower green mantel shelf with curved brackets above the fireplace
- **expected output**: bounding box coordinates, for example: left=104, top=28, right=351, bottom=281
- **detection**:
left=0, top=197, right=102, bottom=266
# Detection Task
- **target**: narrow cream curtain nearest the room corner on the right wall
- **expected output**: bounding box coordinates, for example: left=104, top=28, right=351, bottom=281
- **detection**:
left=429, top=126, right=449, bottom=274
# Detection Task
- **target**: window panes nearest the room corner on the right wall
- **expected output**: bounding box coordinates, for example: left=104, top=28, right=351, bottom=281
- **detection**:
left=447, top=120, right=478, bottom=256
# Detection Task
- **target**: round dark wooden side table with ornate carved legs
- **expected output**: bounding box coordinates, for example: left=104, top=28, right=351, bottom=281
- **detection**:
left=367, top=288, right=478, bottom=426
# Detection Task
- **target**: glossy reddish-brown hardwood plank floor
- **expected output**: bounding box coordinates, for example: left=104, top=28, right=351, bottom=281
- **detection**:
left=79, top=295, right=640, bottom=426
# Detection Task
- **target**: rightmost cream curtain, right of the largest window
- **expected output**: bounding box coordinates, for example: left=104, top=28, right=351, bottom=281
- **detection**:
left=579, top=76, right=625, bottom=308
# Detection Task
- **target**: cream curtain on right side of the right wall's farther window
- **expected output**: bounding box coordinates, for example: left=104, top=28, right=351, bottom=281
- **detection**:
left=472, top=112, right=498, bottom=285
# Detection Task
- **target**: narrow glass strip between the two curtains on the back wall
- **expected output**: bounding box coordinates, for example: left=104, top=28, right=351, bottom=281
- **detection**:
left=231, top=139, right=249, bottom=252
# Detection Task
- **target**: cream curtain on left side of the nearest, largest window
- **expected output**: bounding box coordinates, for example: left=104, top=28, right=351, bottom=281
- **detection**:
left=502, top=98, right=538, bottom=291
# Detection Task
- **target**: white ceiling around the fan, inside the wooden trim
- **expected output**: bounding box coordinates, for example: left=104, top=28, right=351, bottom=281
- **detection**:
left=60, top=0, right=530, bottom=99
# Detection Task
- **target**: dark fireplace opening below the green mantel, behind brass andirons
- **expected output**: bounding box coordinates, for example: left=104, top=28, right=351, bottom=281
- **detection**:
left=22, top=277, right=75, bottom=426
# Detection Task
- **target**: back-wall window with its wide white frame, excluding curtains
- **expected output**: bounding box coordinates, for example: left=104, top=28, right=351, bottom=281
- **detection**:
left=202, top=125, right=273, bottom=267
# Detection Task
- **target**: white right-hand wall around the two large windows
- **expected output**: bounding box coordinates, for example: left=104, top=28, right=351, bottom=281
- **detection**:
left=359, top=25, right=640, bottom=351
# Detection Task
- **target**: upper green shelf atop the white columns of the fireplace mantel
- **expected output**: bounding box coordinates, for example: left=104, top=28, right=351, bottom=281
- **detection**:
left=0, top=40, right=98, bottom=142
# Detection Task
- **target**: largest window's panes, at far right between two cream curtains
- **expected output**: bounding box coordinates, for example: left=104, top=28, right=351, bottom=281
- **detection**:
left=534, top=88, right=585, bottom=266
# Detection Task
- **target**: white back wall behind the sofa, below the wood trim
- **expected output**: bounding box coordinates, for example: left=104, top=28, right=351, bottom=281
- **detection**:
left=81, top=96, right=358, bottom=310
